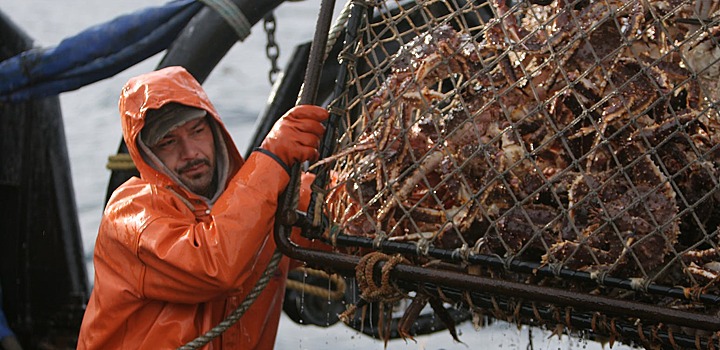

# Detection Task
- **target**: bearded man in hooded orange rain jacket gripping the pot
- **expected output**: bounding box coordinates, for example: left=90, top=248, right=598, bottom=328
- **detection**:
left=78, top=67, right=328, bottom=349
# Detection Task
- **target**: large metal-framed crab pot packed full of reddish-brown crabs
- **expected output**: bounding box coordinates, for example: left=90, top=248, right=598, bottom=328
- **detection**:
left=275, top=0, right=720, bottom=348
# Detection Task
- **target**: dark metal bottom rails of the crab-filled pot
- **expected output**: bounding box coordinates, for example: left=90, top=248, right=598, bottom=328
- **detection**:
left=275, top=221, right=720, bottom=348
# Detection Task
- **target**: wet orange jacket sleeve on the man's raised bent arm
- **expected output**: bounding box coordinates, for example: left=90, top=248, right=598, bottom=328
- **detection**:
left=126, top=152, right=289, bottom=303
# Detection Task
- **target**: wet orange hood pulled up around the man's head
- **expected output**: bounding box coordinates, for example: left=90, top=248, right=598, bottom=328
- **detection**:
left=119, top=66, right=243, bottom=198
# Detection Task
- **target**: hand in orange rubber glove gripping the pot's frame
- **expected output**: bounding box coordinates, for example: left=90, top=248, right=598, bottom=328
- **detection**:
left=260, top=105, right=329, bottom=169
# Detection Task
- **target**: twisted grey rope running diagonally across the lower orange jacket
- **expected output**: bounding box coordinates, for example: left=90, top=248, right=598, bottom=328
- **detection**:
left=178, top=250, right=283, bottom=350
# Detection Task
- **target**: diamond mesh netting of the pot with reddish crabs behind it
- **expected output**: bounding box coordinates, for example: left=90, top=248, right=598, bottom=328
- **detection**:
left=319, top=0, right=720, bottom=346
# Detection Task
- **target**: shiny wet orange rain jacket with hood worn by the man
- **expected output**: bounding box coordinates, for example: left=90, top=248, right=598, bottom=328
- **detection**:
left=78, top=67, right=318, bottom=349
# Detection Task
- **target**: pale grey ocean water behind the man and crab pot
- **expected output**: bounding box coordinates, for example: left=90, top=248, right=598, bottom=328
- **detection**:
left=0, top=0, right=627, bottom=349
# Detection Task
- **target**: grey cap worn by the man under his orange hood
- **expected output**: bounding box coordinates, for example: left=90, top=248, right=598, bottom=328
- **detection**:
left=140, top=103, right=207, bottom=147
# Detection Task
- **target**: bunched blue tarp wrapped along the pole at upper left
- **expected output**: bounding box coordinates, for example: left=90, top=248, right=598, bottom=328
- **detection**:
left=0, top=0, right=203, bottom=102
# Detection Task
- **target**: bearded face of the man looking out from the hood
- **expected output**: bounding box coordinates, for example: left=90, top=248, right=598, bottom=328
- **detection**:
left=150, top=117, right=215, bottom=197
